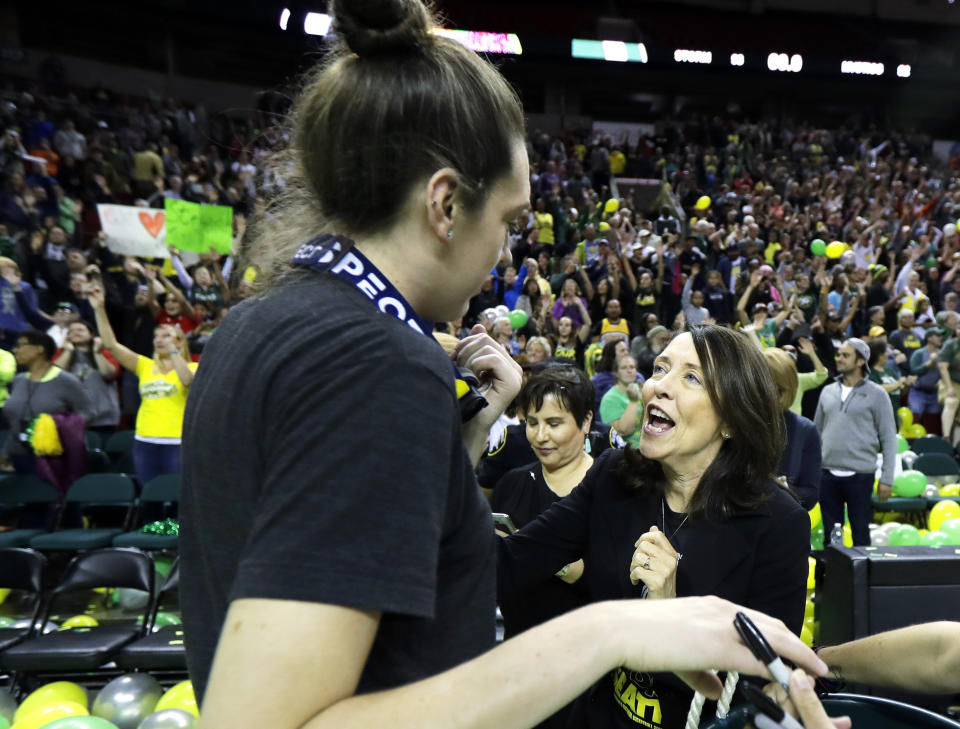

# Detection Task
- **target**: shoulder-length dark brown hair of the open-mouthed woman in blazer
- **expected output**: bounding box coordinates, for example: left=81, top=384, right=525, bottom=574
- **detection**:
left=619, top=325, right=786, bottom=519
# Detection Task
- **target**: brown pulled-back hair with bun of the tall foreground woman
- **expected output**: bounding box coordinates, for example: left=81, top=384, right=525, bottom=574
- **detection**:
left=292, top=0, right=524, bottom=234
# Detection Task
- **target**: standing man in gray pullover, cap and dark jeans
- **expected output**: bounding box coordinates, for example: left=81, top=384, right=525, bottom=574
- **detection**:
left=814, top=338, right=897, bottom=546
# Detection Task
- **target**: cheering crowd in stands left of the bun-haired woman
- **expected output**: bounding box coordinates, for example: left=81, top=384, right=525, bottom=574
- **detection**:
left=0, top=82, right=270, bottom=480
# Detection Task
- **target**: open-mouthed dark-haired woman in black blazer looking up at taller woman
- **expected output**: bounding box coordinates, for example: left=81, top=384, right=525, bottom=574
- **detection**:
left=498, top=326, right=810, bottom=729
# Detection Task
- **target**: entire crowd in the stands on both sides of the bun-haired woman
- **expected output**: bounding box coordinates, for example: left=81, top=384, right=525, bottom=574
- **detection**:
left=0, top=74, right=960, bottom=490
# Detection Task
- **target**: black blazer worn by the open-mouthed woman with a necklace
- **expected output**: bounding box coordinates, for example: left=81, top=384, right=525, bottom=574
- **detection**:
left=497, top=450, right=810, bottom=727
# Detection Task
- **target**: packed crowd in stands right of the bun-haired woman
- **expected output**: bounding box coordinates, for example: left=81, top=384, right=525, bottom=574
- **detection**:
left=462, top=118, right=960, bottom=435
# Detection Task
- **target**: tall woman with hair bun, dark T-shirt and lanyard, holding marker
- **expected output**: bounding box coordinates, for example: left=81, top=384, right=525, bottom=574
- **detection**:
left=180, top=0, right=827, bottom=729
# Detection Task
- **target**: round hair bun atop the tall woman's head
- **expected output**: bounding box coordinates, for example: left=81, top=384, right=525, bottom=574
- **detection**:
left=331, top=0, right=432, bottom=57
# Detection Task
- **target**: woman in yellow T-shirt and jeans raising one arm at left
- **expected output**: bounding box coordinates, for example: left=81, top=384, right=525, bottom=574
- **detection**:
left=89, top=285, right=197, bottom=484
